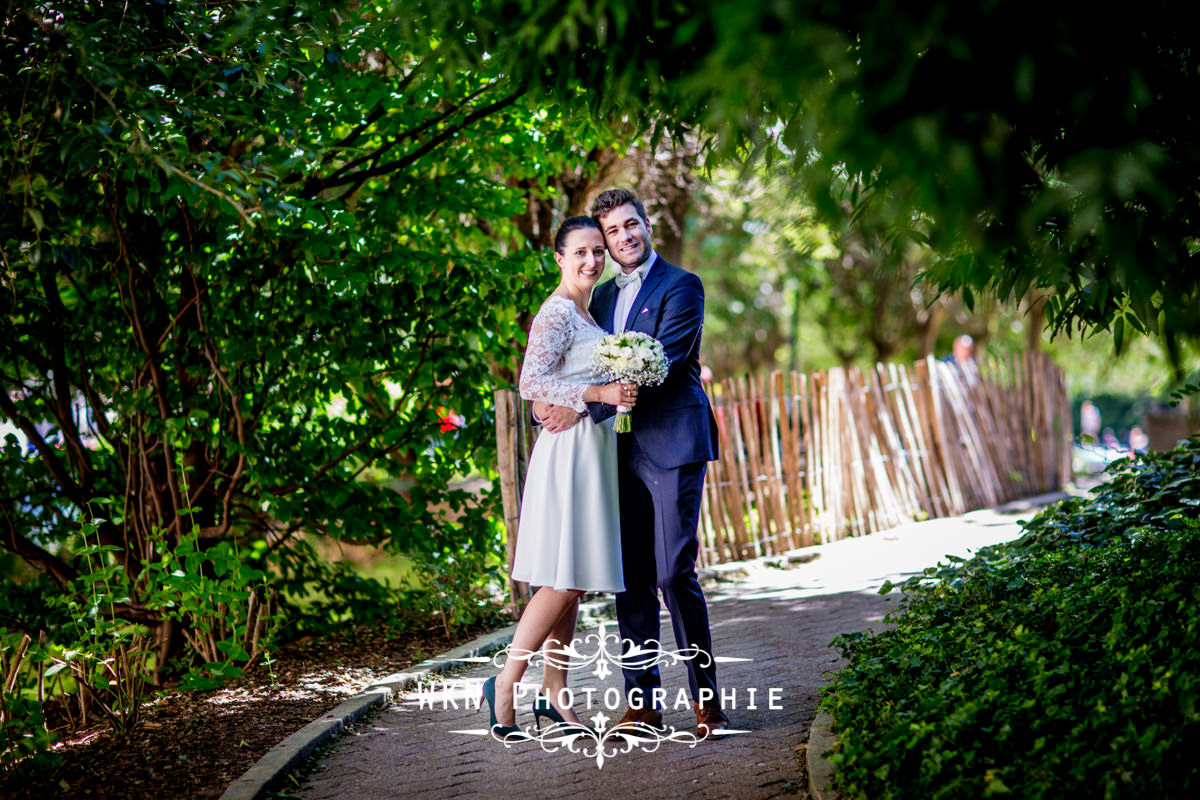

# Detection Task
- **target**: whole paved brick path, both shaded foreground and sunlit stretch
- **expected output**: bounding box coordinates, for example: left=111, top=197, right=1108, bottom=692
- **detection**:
left=299, top=511, right=1031, bottom=800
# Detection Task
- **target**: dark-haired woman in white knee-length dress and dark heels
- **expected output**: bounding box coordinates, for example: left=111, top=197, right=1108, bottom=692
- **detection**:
left=484, top=217, right=637, bottom=738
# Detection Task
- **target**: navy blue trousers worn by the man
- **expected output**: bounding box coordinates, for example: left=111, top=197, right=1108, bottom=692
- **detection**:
left=617, top=434, right=718, bottom=708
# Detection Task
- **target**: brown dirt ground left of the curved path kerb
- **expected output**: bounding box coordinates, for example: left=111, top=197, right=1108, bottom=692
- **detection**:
left=0, top=627, right=485, bottom=800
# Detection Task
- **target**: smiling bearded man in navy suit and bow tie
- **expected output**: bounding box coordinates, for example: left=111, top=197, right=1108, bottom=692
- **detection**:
left=534, top=190, right=730, bottom=735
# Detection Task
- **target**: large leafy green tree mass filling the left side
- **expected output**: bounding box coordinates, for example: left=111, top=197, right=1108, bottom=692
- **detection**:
left=0, top=0, right=601, bottom=669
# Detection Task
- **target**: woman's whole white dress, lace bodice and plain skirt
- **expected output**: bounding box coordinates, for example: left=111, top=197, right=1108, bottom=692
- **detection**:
left=512, top=295, right=625, bottom=591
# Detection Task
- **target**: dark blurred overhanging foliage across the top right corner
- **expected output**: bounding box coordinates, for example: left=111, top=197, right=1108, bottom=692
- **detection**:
left=424, top=0, right=1200, bottom=361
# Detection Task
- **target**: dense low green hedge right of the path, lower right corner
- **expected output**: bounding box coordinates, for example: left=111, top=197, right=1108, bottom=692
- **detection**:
left=824, top=439, right=1200, bottom=800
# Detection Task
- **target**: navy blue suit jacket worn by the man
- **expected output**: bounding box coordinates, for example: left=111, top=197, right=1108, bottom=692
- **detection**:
left=588, top=255, right=716, bottom=469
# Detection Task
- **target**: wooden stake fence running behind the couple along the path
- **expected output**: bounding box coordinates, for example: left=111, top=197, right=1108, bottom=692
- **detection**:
left=496, top=353, right=1073, bottom=573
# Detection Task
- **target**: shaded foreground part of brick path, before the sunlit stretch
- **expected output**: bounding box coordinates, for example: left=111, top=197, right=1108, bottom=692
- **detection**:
left=299, top=585, right=892, bottom=800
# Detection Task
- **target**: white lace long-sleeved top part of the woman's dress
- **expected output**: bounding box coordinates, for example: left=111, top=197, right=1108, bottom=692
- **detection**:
left=520, top=295, right=606, bottom=414
